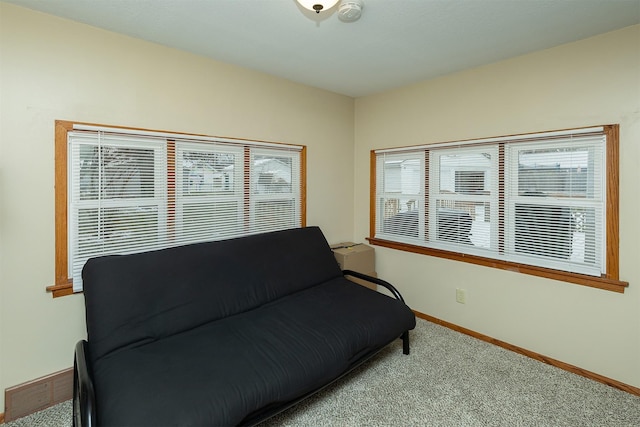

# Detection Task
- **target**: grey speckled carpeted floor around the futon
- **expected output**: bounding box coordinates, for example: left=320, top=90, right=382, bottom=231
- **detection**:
left=6, top=319, right=640, bottom=427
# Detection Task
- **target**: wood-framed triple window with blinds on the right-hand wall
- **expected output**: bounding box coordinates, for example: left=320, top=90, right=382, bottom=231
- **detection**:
left=369, top=125, right=627, bottom=292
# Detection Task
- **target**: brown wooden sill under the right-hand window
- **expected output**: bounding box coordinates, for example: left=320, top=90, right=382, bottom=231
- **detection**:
left=367, top=237, right=629, bottom=293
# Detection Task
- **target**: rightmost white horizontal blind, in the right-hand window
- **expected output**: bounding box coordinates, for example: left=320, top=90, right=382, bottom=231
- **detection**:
left=505, top=136, right=606, bottom=275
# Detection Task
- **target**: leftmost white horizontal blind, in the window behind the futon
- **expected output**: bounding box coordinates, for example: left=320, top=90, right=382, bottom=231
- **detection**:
left=68, top=132, right=167, bottom=291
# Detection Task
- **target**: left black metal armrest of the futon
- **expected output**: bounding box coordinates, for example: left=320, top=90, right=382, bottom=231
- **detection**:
left=73, top=340, right=98, bottom=427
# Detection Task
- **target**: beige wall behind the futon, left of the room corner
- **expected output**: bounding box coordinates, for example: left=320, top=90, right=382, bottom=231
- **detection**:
left=0, top=3, right=354, bottom=412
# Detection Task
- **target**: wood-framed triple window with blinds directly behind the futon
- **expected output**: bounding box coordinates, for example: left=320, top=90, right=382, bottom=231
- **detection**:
left=48, top=121, right=305, bottom=296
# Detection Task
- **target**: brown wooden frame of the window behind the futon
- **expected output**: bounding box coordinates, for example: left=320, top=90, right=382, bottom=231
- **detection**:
left=46, top=120, right=307, bottom=298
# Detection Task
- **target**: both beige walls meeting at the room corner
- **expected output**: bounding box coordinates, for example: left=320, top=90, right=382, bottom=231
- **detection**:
left=0, top=3, right=640, bottom=414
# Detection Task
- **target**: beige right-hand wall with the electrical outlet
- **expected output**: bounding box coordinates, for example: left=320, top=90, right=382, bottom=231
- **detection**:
left=354, top=26, right=640, bottom=387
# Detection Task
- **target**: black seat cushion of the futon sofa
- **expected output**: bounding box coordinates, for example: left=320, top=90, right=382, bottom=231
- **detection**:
left=93, top=277, right=415, bottom=426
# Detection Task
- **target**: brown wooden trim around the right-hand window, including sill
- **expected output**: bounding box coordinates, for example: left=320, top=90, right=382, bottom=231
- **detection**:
left=367, top=124, right=629, bottom=293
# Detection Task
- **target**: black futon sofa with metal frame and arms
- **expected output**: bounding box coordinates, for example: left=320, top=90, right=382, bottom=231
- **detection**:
left=73, top=227, right=415, bottom=426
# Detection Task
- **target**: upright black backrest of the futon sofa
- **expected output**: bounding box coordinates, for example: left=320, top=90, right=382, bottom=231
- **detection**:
left=82, top=227, right=342, bottom=361
